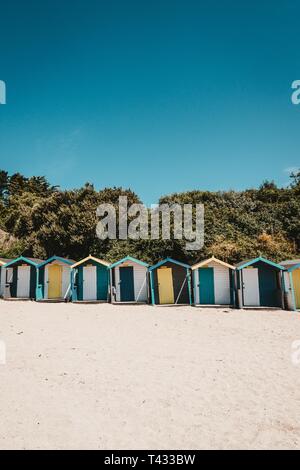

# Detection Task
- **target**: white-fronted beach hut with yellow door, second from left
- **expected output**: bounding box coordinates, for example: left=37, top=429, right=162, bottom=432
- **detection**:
left=36, top=256, right=75, bottom=301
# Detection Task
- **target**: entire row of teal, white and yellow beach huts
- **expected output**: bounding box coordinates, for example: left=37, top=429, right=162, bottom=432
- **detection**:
left=0, top=256, right=300, bottom=310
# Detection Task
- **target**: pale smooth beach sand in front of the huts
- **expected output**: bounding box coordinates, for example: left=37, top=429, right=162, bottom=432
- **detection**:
left=0, top=301, right=300, bottom=450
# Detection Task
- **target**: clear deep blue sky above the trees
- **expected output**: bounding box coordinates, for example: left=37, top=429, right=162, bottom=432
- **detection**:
left=0, top=0, right=300, bottom=204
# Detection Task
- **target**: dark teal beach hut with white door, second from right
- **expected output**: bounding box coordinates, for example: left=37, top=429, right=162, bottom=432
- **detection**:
left=235, top=256, right=284, bottom=308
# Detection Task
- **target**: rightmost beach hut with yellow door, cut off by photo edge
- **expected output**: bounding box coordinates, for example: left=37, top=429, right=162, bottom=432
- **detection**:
left=280, top=259, right=300, bottom=310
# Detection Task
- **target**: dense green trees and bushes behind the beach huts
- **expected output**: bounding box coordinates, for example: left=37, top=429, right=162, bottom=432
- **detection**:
left=0, top=171, right=300, bottom=262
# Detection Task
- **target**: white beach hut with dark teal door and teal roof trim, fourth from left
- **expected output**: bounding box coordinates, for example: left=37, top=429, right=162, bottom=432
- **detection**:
left=109, top=256, right=149, bottom=303
